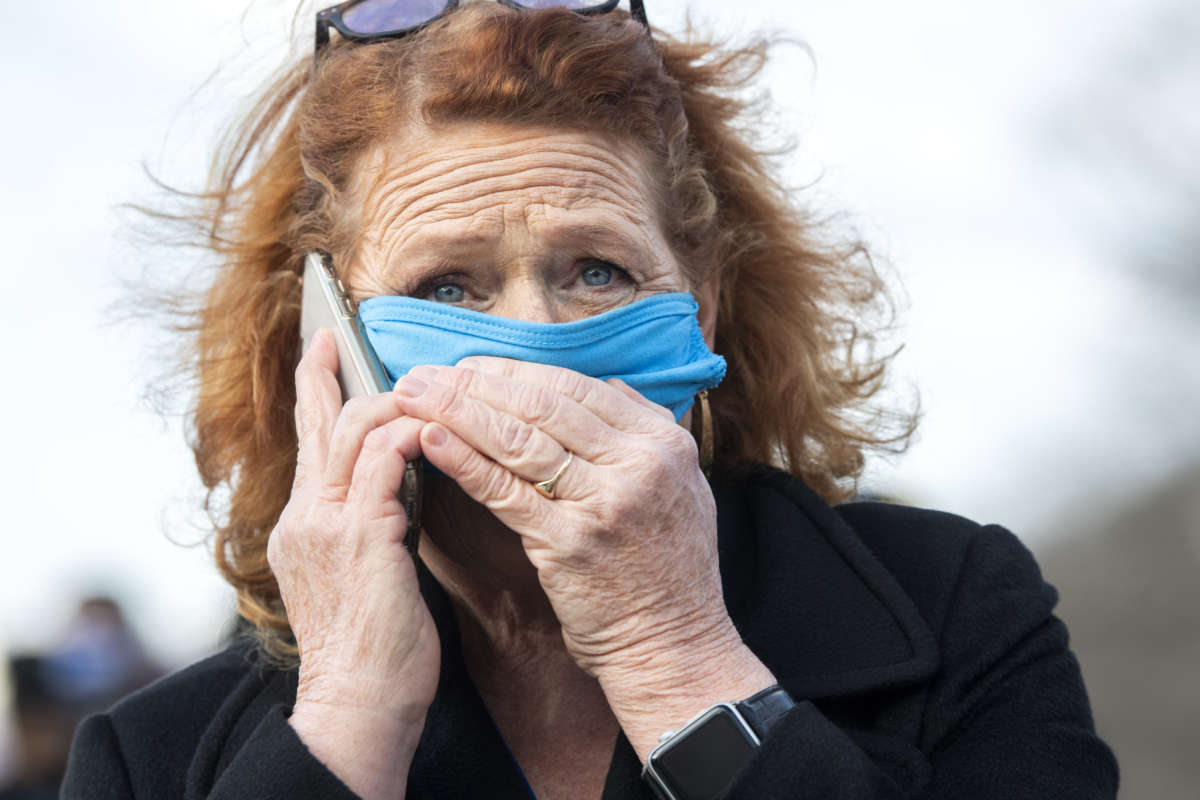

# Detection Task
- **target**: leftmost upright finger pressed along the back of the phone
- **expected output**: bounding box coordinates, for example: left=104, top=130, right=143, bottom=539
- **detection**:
left=294, top=329, right=342, bottom=486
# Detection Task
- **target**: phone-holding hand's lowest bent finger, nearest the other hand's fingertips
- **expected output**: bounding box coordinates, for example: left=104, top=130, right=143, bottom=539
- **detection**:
left=346, top=416, right=425, bottom=527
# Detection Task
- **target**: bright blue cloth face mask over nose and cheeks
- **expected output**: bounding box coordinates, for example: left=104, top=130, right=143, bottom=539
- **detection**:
left=359, top=293, right=725, bottom=421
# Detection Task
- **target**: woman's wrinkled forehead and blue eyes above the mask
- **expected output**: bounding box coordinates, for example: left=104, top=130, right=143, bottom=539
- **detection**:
left=348, top=124, right=712, bottom=335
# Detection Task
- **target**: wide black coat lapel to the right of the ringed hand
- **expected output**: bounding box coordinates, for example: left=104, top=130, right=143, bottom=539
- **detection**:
left=714, top=467, right=938, bottom=699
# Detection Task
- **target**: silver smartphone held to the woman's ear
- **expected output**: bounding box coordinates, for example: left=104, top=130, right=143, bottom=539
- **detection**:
left=300, top=251, right=424, bottom=558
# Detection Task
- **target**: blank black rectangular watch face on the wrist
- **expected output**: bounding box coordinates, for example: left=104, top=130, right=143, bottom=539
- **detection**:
left=654, top=705, right=756, bottom=800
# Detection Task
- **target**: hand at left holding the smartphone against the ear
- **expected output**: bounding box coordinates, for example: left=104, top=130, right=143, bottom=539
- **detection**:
left=266, top=331, right=440, bottom=798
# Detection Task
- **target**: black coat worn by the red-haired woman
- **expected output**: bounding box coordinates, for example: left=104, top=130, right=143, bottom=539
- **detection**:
left=62, top=469, right=1117, bottom=800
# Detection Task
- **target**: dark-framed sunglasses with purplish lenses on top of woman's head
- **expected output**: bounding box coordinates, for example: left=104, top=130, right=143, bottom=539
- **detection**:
left=316, top=0, right=649, bottom=53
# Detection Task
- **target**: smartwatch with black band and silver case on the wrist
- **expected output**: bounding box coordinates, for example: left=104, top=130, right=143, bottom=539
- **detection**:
left=642, top=685, right=796, bottom=800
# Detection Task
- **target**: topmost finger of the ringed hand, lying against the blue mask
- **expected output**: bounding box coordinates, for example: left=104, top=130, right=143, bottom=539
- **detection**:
left=457, top=356, right=674, bottom=433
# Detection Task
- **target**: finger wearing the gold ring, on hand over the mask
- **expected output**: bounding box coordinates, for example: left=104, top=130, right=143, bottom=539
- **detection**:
left=395, top=371, right=600, bottom=489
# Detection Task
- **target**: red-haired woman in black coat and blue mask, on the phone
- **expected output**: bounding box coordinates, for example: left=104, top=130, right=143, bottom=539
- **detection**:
left=64, top=0, right=1116, bottom=799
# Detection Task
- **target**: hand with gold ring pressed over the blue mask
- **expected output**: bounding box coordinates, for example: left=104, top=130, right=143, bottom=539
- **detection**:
left=396, top=357, right=774, bottom=754
